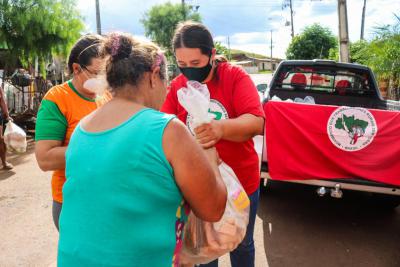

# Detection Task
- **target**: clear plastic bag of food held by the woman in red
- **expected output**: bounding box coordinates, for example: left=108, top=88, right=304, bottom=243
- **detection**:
left=178, top=81, right=250, bottom=265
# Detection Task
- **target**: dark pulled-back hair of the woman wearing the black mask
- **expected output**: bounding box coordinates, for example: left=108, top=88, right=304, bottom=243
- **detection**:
left=172, top=21, right=227, bottom=62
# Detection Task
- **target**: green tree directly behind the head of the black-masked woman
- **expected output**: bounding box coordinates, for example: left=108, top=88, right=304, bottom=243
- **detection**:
left=141, top=2, right=201, bottom=57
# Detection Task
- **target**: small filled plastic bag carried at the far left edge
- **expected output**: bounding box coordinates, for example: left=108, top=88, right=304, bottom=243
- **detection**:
left=4, top=121, right=27, bottom=153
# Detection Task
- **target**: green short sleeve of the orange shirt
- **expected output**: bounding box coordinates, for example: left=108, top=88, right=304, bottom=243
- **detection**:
left=35, top=99, right=68, bottom=141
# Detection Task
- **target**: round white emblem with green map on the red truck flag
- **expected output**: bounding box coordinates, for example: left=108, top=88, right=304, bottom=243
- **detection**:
left=327, top=107, right=378, bottom=151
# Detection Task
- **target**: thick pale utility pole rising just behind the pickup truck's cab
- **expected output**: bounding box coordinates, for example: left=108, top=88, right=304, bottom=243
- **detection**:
left=338, top=0, right=350, bottom=62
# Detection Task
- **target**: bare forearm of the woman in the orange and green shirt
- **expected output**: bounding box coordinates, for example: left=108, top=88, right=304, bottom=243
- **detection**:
left=36, top=146, right=67, bottom=171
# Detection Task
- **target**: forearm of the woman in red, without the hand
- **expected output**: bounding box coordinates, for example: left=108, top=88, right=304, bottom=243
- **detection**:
left=218, top=114, right=264, bottom=142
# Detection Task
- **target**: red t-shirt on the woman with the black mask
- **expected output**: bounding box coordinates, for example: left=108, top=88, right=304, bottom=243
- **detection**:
left=161, top=63, right=264, bottom=195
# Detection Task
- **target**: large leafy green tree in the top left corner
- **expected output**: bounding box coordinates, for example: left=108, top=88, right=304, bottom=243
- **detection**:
left=0, top=0, right=84, bottom=75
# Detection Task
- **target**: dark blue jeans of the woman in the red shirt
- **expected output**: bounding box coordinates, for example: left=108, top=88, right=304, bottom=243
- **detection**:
left=199, top=188, right=260, bottom=267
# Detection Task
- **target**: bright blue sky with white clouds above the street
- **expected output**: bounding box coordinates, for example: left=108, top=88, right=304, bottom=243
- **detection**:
left=77, top=0, right=400, bottom=58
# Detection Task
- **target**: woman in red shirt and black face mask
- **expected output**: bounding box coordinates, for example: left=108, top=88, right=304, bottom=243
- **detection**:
left=161, top=22, right=264, bottom=267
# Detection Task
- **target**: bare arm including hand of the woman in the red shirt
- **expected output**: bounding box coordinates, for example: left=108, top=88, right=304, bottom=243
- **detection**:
left=195, top=114, right=264, bottom=148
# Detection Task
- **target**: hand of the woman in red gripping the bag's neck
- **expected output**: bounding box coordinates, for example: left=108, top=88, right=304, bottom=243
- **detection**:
left=194, top=120, right=224, bottom=149
